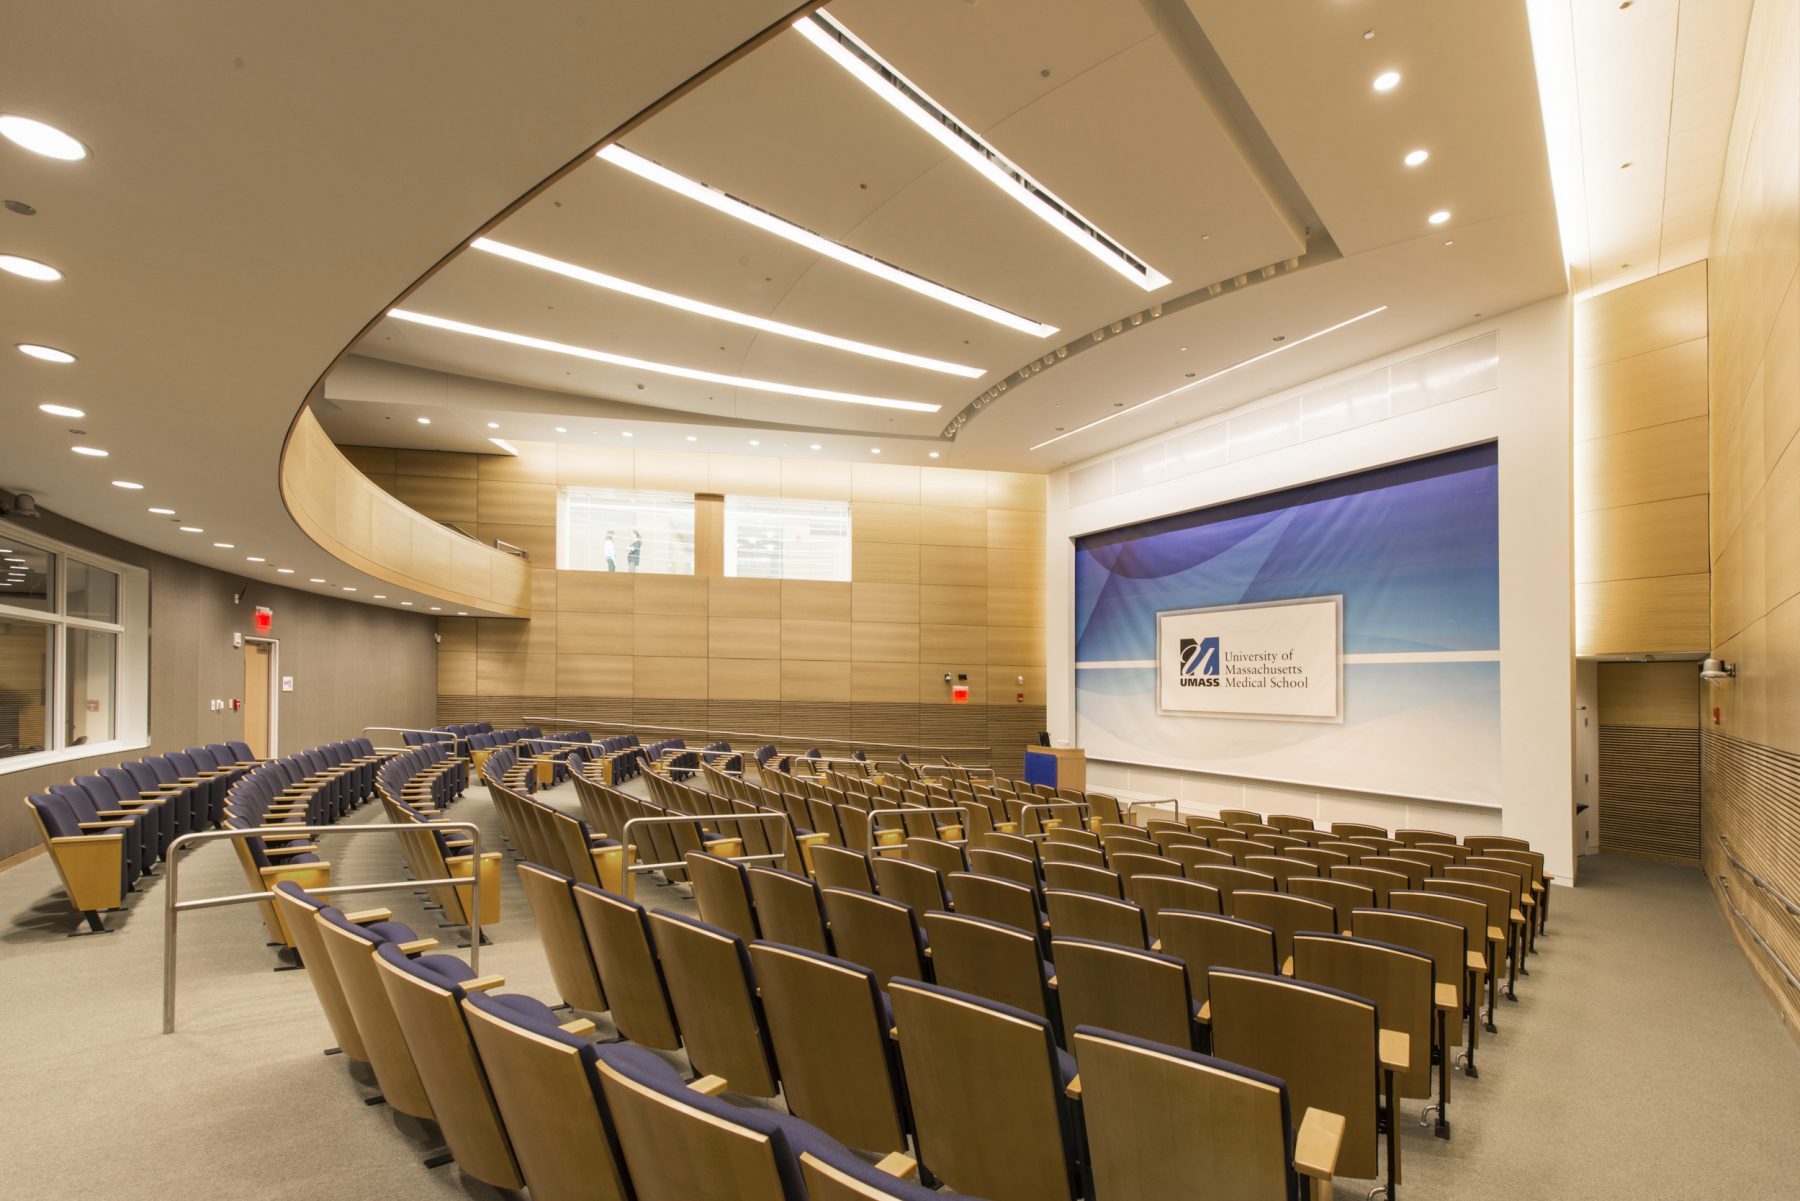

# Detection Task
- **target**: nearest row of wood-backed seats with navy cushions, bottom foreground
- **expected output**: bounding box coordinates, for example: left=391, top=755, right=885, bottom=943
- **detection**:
left=275, top=884, right=941, bottom=1201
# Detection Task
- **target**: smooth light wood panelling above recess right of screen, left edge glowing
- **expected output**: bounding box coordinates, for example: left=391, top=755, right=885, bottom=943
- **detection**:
left=1575, top=263, right=1710, bottom=655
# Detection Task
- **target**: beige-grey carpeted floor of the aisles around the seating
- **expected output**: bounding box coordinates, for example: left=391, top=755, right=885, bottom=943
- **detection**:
left=0, top=787, right=1800, bottom=1201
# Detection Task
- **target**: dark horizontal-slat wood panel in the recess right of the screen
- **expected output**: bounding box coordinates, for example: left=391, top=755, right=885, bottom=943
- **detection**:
left=1600, top=724, right=1699, bottom=864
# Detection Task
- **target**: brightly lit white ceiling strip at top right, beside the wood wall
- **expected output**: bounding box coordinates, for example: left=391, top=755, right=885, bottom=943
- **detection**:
left=1544, top=0, right=1751, bottom=292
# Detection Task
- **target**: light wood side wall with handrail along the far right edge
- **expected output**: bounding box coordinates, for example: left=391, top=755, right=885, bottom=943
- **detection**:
left=1701, top=0, right=1800, bottom=1025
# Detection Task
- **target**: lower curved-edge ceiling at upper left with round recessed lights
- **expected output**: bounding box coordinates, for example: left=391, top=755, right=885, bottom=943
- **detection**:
left=0, top=0, right=790, bottom=607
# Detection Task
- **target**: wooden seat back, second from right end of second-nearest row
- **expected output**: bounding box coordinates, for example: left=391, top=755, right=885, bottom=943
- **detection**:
left=889, top=983, right=1075, bottom=1201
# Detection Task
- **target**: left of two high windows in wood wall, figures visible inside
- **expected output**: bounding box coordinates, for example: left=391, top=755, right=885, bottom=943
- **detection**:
left=558, top=488, right=693, bottom=576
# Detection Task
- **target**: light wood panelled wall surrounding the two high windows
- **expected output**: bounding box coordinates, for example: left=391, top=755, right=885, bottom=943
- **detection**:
left=342, top=443, right=1044, bottom=772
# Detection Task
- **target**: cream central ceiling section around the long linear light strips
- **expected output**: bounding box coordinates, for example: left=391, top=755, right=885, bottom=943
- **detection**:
left=331, top=0, right=1564, bottom=470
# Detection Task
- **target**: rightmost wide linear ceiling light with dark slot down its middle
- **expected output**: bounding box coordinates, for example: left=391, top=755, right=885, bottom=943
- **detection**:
left=794, top=13, right=1168, bottom=292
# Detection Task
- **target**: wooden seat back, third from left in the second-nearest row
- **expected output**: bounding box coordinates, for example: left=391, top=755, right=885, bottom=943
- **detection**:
left=650, top=909, right=776, bottom=1097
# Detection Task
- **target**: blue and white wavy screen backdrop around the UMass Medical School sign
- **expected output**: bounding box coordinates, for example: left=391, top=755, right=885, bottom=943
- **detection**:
left=1075, top=443, right=1499, bottom=799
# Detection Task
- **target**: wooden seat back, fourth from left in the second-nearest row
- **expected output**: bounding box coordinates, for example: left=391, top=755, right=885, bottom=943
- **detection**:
left=748, top=942, right=905, bottom=1154
